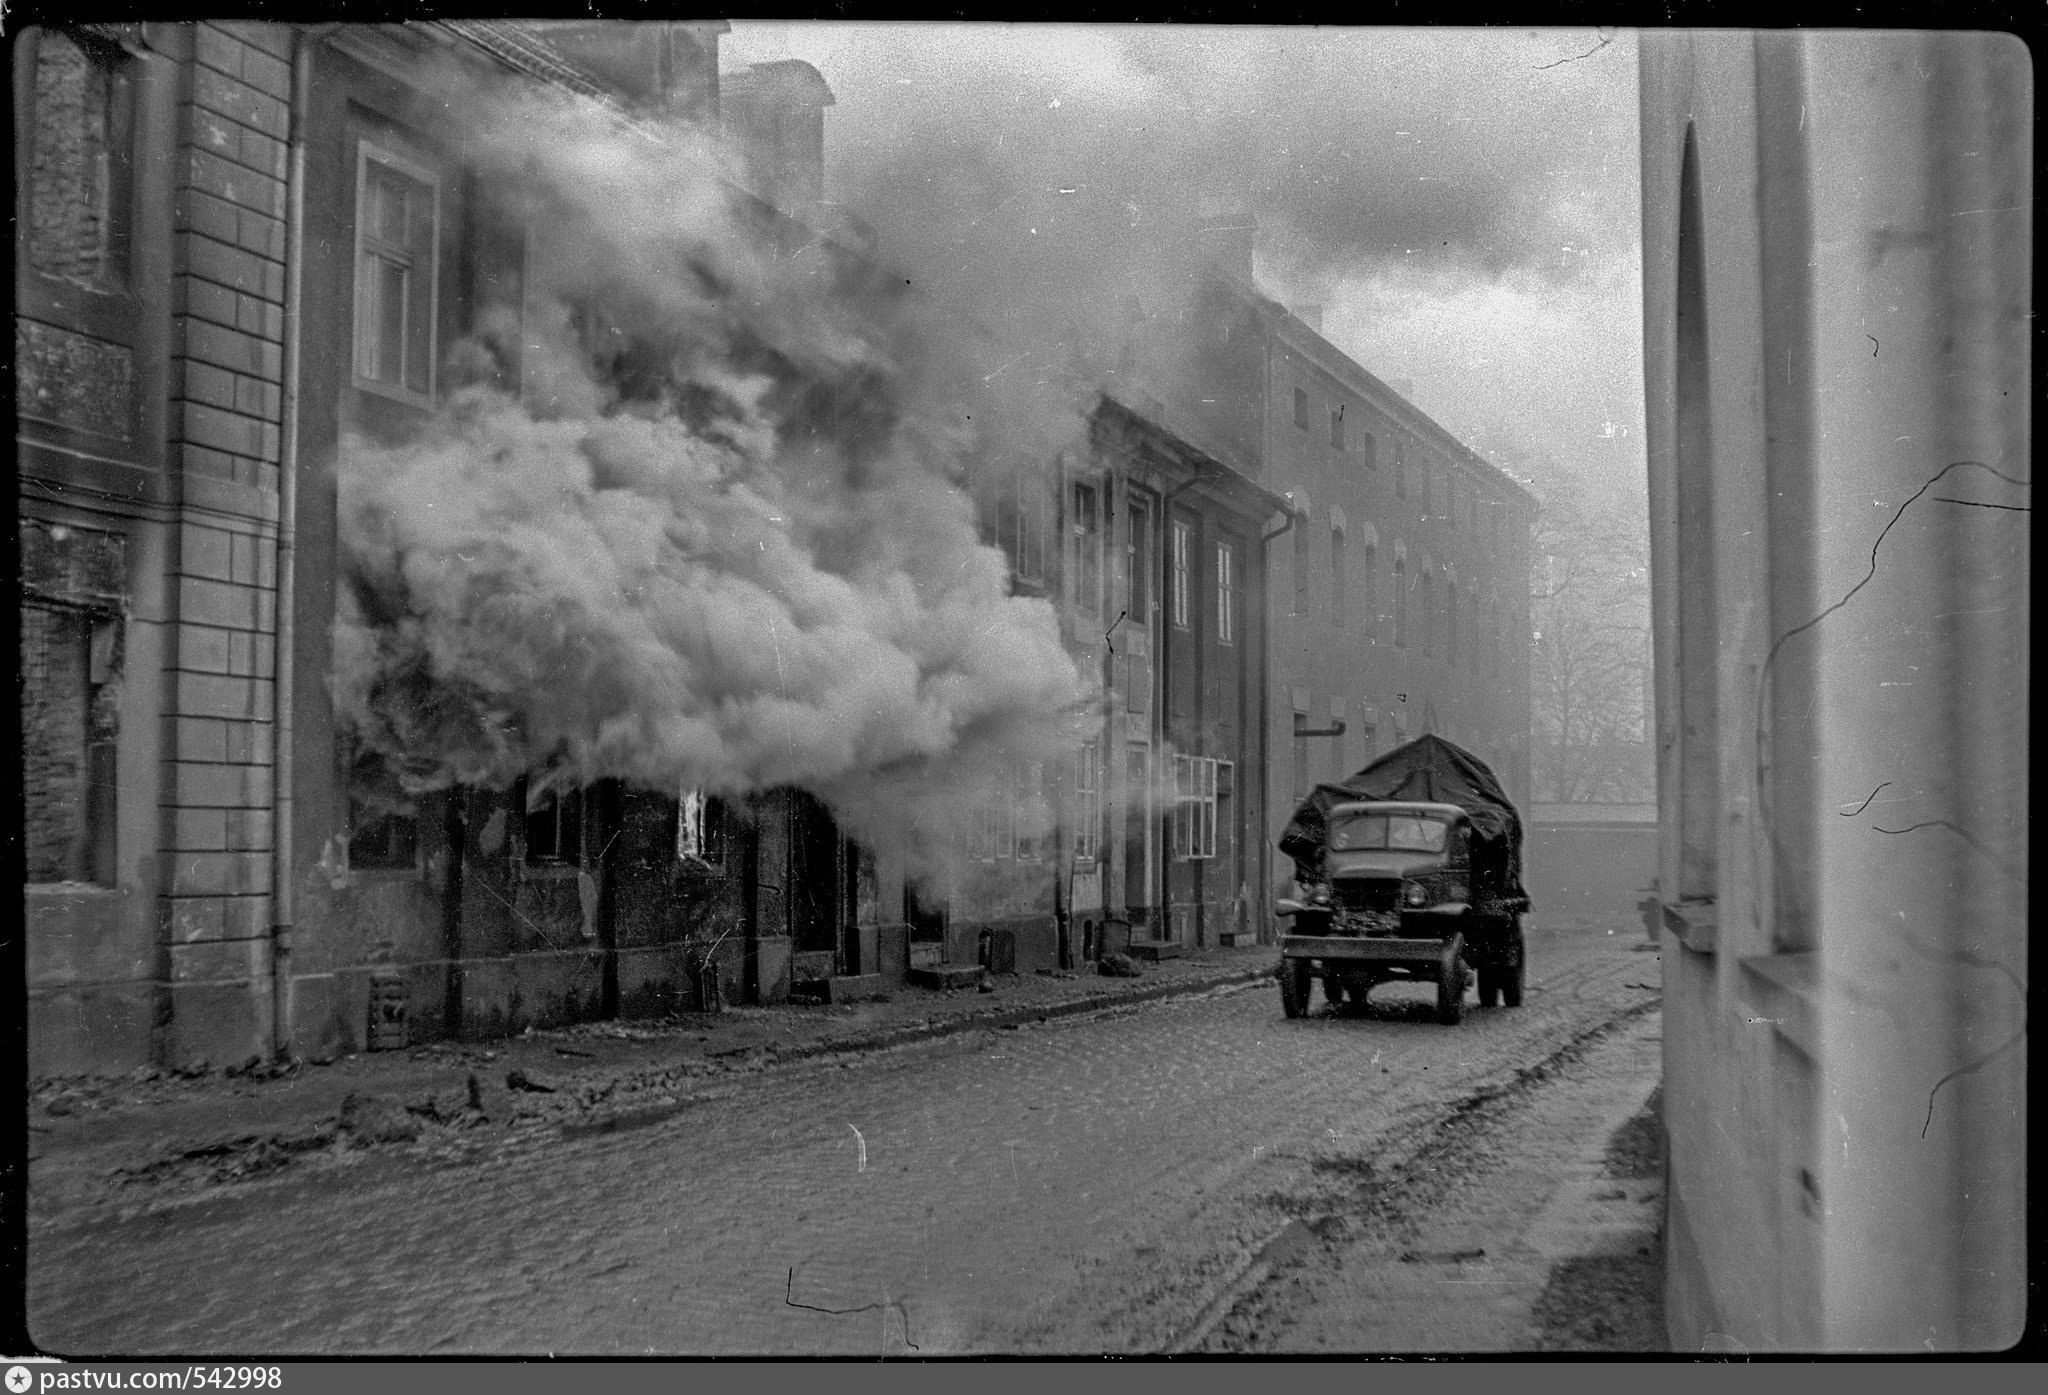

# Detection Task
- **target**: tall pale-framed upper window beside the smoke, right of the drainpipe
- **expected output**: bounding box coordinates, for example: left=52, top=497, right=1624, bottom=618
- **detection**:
left=356, top=141, right=440, bottom=406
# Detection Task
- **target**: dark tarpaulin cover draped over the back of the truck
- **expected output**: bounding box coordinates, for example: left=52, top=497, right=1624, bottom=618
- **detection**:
left=1280, top=735, right=1528, bottom=907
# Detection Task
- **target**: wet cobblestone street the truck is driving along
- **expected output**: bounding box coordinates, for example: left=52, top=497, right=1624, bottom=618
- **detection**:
left=29, top=928, right=1657, bottom=1356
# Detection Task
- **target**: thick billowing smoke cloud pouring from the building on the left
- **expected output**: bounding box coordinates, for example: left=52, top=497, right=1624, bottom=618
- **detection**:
left=334, top=73, right=1094, bottom=860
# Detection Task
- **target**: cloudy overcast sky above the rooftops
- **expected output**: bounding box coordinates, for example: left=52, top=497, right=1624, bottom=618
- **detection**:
left=725, top=20, right=1642, bottom=498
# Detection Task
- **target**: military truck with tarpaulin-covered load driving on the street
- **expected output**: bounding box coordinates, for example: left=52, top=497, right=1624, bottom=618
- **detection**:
left=1276, top=735, right=1530, bottom=1024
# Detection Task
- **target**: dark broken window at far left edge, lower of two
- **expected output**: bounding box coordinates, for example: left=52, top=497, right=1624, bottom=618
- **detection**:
left=20, top=604, right=121, bottom=885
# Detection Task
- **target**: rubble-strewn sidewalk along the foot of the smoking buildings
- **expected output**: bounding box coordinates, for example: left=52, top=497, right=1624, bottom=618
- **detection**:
left=29, top=944, right=1276, bottom=1215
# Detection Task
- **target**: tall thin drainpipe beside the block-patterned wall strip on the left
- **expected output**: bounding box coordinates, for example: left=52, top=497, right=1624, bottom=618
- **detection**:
left=270, top=25, right=340, bottom=1061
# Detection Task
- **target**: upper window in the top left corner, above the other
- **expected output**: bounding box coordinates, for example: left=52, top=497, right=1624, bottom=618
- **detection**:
left=25, top=29, right=135, bottom=287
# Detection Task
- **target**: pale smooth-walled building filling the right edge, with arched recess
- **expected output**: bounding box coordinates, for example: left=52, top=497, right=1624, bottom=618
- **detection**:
left=1638, top=33, right=2038, bottom=1352
